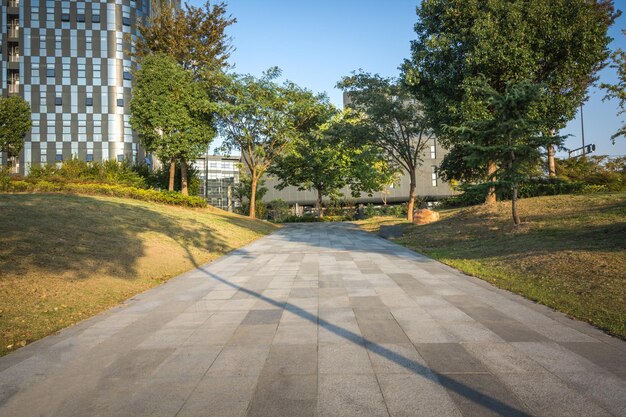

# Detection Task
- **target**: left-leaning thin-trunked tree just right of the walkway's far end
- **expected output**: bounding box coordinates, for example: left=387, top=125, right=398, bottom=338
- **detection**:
left=337, top=72, right=432, bottom=222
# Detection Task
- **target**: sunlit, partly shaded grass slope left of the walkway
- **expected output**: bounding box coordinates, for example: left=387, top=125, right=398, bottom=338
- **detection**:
left=0, top=194, right=275, bottom=355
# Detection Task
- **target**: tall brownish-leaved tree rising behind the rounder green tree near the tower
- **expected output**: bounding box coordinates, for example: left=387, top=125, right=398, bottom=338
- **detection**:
left=135, top=0, right=237, bottom=185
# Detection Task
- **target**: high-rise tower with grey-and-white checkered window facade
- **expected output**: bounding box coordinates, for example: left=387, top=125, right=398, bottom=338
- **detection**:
left=0, top=0, right=180, bottom=173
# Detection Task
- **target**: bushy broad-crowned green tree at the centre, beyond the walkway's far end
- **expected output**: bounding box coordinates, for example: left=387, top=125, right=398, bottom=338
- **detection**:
left=268, top=107, right=386, bottom=218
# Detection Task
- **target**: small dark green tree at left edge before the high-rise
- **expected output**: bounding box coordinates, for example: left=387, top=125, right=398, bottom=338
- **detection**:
left=0, top=96, right=32, bottom=169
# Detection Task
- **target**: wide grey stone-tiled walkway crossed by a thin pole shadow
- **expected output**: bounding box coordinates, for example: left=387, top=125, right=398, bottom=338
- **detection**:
left=0, top=224, right=626, bottom=417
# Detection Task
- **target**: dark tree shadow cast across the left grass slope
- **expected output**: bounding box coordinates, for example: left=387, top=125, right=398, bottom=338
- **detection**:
left=0, top=194, right=236, bottom=279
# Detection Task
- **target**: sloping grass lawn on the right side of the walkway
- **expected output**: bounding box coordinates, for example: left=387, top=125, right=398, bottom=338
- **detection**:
left=359, top=193, right=626, bottom=339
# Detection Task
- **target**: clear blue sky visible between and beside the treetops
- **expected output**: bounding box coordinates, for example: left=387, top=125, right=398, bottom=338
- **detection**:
left=188, top=0, right=626, bottom=156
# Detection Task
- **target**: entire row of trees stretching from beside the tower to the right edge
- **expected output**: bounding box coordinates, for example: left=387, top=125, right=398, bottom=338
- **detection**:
left=131, top=0, right=623, bottom=224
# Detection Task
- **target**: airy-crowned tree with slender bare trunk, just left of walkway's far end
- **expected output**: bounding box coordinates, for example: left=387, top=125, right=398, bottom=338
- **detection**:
left=220, top=67, right=319, bottom=218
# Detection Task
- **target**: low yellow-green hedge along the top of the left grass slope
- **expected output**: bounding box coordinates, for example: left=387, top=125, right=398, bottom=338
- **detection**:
left=6, top=181, right=207, bottom=207
